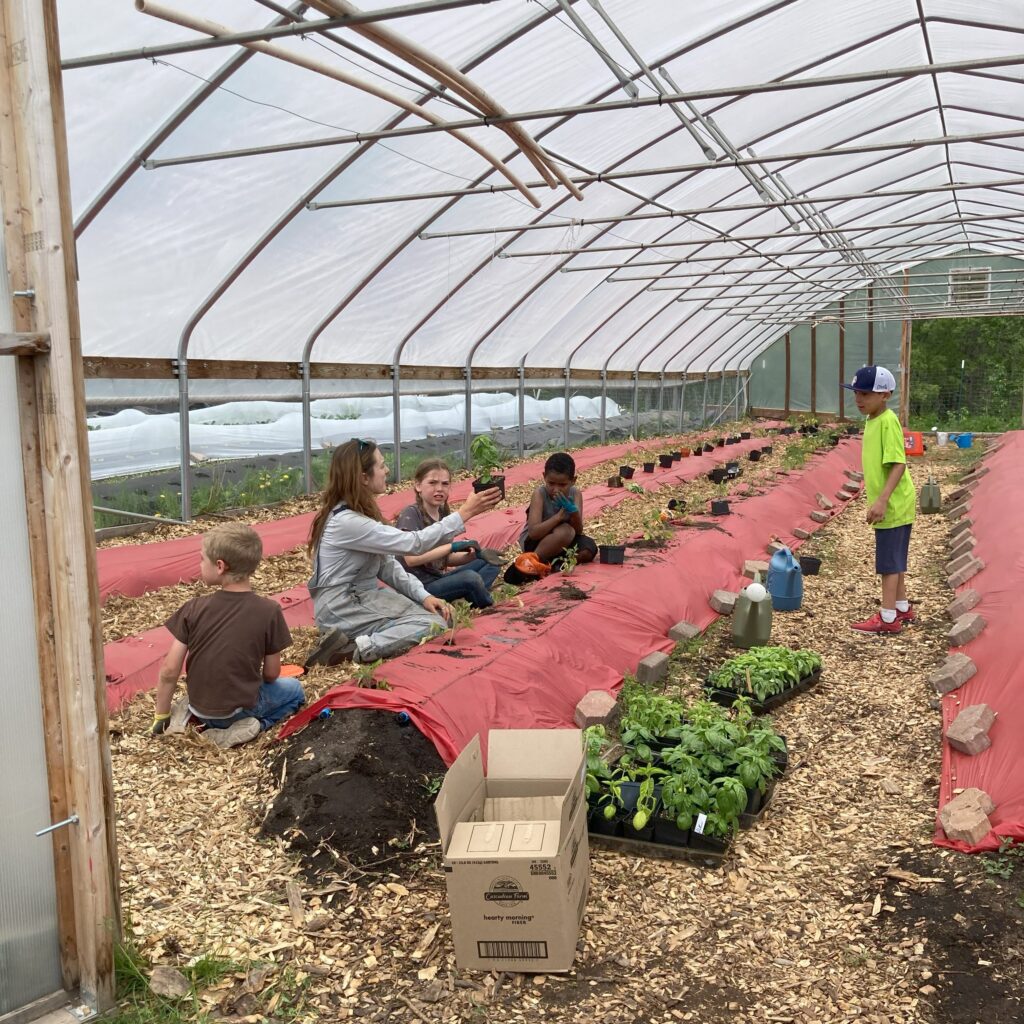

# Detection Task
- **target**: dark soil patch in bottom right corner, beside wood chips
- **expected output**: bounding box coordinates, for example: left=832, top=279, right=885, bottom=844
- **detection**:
left=879, top=850, right=1024, bottom=1024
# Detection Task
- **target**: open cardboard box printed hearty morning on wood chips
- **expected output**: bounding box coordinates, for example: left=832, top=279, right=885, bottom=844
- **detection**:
left=434, top=729, right=590, bottom=974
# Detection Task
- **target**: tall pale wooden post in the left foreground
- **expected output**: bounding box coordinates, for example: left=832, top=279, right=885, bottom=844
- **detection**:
left=0, top=0, right=120, bottom=1011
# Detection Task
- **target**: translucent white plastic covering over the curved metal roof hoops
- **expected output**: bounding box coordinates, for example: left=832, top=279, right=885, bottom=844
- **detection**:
left=57, top=0, right=1024, bottom=373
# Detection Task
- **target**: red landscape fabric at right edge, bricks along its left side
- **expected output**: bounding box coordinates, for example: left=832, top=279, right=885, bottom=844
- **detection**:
left=935, top=431, right=1024, bottom=853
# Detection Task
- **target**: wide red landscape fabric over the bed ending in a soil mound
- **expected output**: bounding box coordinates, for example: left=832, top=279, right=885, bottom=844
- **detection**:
left=281, top=441, right=860, bottom=764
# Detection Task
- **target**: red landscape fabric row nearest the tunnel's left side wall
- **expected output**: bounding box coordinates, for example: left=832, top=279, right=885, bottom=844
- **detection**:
left=96, top=423, right=773, bottom=603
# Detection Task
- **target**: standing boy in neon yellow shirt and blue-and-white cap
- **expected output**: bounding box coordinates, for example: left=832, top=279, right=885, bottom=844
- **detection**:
left=843, top=367, right=918, bottom=633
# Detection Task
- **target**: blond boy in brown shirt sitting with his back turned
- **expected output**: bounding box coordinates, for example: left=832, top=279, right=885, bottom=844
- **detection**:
left=150, top=523, right=306, bottom=748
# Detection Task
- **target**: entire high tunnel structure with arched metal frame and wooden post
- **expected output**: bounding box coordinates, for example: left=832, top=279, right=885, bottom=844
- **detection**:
left=6, top=0, right=1024, bottom=1017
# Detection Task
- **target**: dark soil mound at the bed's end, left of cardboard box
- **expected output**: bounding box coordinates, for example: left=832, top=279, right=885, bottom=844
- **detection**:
left=263, top=711, right=444, bottom=873
